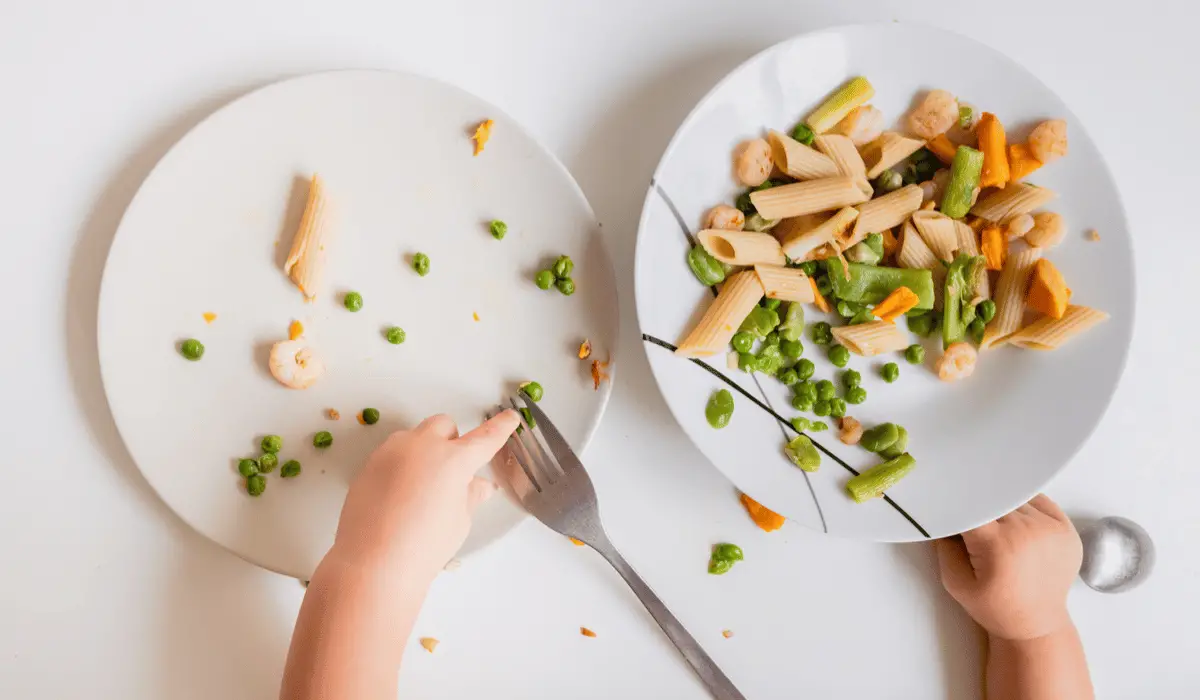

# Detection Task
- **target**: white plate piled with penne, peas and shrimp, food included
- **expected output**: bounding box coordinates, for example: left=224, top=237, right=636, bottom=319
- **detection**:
left=635, top=23, right=1135, bottom=542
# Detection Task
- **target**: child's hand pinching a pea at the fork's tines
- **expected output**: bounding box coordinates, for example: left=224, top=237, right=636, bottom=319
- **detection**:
left=330, top=411, right=520, bottom=580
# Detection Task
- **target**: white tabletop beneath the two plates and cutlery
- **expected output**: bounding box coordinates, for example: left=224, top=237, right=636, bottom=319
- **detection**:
left=0, top=0, right=1200, bottom=700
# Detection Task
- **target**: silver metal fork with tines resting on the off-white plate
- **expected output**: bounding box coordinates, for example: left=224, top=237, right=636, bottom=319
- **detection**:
left=496, top=396, right=745, bottom=700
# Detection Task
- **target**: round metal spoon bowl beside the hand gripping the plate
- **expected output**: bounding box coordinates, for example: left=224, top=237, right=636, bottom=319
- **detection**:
left=1079, top=516, right=1154, bottom=593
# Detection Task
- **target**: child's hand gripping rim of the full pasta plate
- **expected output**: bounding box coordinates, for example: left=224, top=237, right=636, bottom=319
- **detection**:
left=935, top=493, right=1084, bottom=640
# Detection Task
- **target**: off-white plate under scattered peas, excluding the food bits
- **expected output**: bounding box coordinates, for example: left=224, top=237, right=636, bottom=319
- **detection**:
left=98, top=71, right=617, bottom=578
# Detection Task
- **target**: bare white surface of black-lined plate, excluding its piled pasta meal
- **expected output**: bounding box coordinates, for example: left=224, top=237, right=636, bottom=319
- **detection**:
left=635, top=24, right=1134, bottom=542
